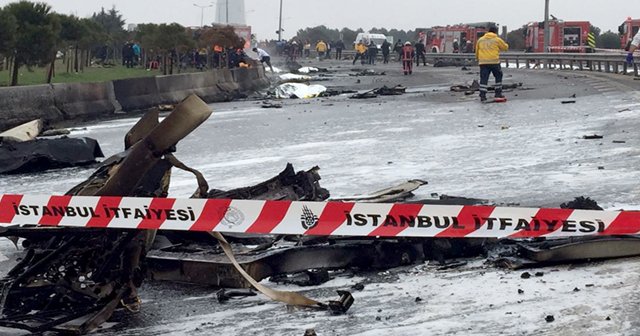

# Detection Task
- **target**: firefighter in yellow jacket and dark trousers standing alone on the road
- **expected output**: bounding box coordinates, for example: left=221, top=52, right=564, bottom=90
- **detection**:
left=476, top=26, right=509, bottom=102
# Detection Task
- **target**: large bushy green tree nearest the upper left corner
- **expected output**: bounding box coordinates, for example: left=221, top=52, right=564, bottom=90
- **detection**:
left=5, top=1, right=60, bottom=86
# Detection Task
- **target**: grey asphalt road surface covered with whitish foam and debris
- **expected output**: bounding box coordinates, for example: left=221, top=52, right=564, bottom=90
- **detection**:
left=0, top=57, right=640, bottom=335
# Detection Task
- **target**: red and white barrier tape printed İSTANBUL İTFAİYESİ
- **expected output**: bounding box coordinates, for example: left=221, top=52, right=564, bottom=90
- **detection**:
left=0, top=195, right=640, bottom=238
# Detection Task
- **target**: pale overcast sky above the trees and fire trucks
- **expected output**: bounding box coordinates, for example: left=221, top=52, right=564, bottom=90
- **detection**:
left=0, top=0, right=640, bottom=40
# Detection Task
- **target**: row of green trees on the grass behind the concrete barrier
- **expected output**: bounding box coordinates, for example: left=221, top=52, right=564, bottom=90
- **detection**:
left=0, top=0, right=244, bottom=86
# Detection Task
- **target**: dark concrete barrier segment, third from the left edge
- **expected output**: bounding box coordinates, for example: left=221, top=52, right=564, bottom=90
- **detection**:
left=113, top=77, right=162, bottom=112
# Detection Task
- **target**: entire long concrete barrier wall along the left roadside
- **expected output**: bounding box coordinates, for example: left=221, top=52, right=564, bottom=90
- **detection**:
left=0, top=66, right=269, bottom=131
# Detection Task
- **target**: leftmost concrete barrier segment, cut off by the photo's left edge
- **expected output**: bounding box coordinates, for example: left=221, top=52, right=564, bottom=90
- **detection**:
left=0, top=85, right=63, bottom=130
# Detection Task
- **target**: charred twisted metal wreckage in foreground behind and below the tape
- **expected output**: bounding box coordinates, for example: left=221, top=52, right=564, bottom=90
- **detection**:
left=0, top=96, right=640, bottom=334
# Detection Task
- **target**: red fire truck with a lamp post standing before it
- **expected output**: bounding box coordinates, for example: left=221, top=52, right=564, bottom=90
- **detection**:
left=525, top=18, right=591, bottom=52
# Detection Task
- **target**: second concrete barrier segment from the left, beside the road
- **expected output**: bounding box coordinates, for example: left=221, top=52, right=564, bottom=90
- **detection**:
left=53, top=82, right=116, bottom=121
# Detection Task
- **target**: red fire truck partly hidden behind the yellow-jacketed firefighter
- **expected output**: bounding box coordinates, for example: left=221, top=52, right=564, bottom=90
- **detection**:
left=420, top=22, right=498, bottom=53
